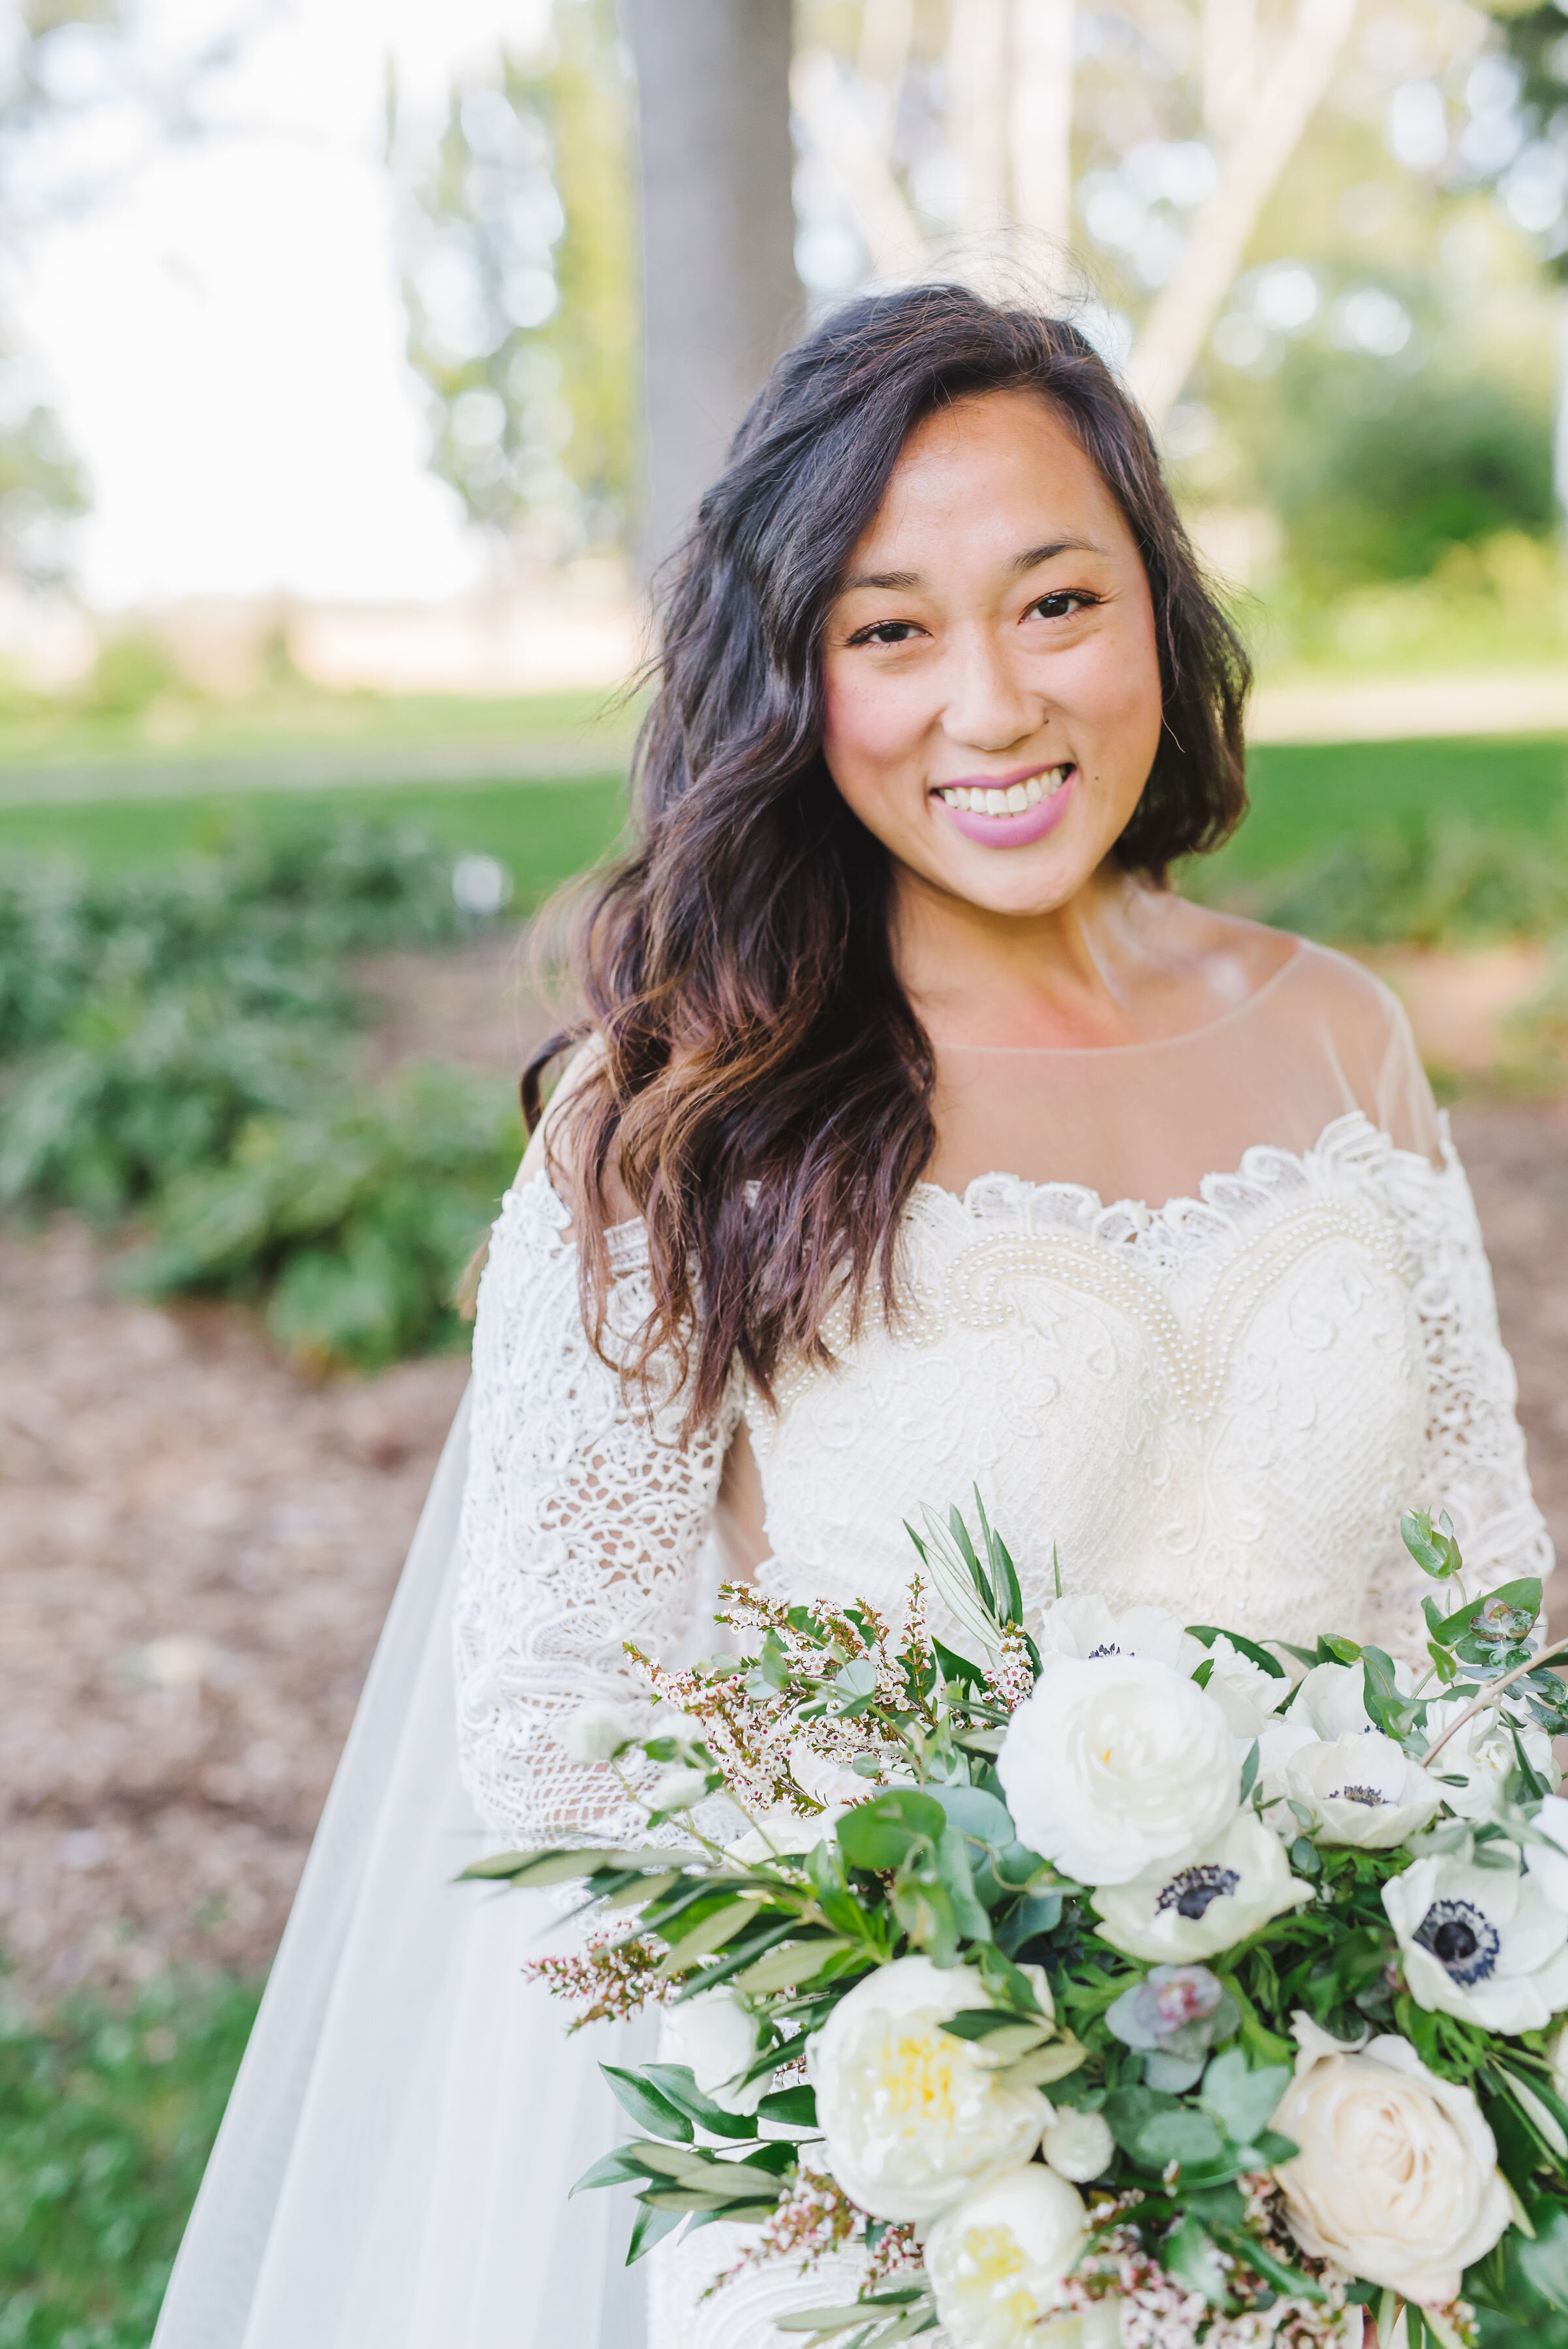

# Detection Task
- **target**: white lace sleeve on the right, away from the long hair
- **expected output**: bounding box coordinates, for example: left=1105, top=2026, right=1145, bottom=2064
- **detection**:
left=1361, top=1120, right=1552, bottom=1656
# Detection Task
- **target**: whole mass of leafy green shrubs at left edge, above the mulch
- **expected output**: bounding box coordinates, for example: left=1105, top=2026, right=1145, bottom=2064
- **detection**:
left=0, top=820, right=521, bottom=1370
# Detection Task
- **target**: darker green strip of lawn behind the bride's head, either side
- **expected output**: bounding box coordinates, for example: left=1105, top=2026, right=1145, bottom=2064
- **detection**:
left=0, top=735, right=1568, bottom=902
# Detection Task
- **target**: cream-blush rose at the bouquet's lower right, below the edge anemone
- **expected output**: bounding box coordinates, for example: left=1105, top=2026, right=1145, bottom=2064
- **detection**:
left=1270, top=2016, right=1512, bottom=2307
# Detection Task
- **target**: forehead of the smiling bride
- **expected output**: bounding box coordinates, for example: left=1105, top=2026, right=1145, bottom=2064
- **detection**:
left=857, top=392, right=1131, bottom=555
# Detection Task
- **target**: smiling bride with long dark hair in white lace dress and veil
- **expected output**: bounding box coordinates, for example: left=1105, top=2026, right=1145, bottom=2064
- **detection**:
left=157, top=286, right=1549, bottom=2349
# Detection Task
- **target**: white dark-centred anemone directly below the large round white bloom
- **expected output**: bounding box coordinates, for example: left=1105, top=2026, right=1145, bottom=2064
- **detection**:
left=1094, top=1811, right=1312, bottom=1966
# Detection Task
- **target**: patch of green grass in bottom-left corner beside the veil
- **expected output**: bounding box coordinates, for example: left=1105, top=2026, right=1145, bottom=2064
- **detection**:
left=0, top=1978, right=256, bottom=2349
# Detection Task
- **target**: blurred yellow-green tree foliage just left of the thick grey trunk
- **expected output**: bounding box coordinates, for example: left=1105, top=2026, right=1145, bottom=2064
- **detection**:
left=388, top=0, right=638, bottom=561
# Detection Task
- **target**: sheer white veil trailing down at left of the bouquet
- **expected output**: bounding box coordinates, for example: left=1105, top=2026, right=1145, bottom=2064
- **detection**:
left=155, top=1400, right=653, bottom=2349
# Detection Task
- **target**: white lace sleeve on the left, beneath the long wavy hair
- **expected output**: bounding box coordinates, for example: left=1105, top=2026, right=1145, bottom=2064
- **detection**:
left=455, top=1174, right=739, bottom=1844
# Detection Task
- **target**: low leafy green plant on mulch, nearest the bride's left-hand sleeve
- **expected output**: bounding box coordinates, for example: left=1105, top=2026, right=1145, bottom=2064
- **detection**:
left=127, top=1069, right=519, bottom=1370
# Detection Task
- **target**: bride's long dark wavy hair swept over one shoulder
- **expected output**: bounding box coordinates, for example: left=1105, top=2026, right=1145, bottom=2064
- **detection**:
left=523, top=284, right=1249, bottom=1433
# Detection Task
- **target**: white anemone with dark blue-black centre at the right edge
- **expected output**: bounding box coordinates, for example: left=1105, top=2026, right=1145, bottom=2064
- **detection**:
left=1383, top=1844, right=1568, bottom=2034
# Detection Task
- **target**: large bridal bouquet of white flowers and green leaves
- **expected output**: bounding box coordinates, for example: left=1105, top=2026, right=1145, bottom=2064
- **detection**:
left=467, top=1496, right=1568, bottom=2349
